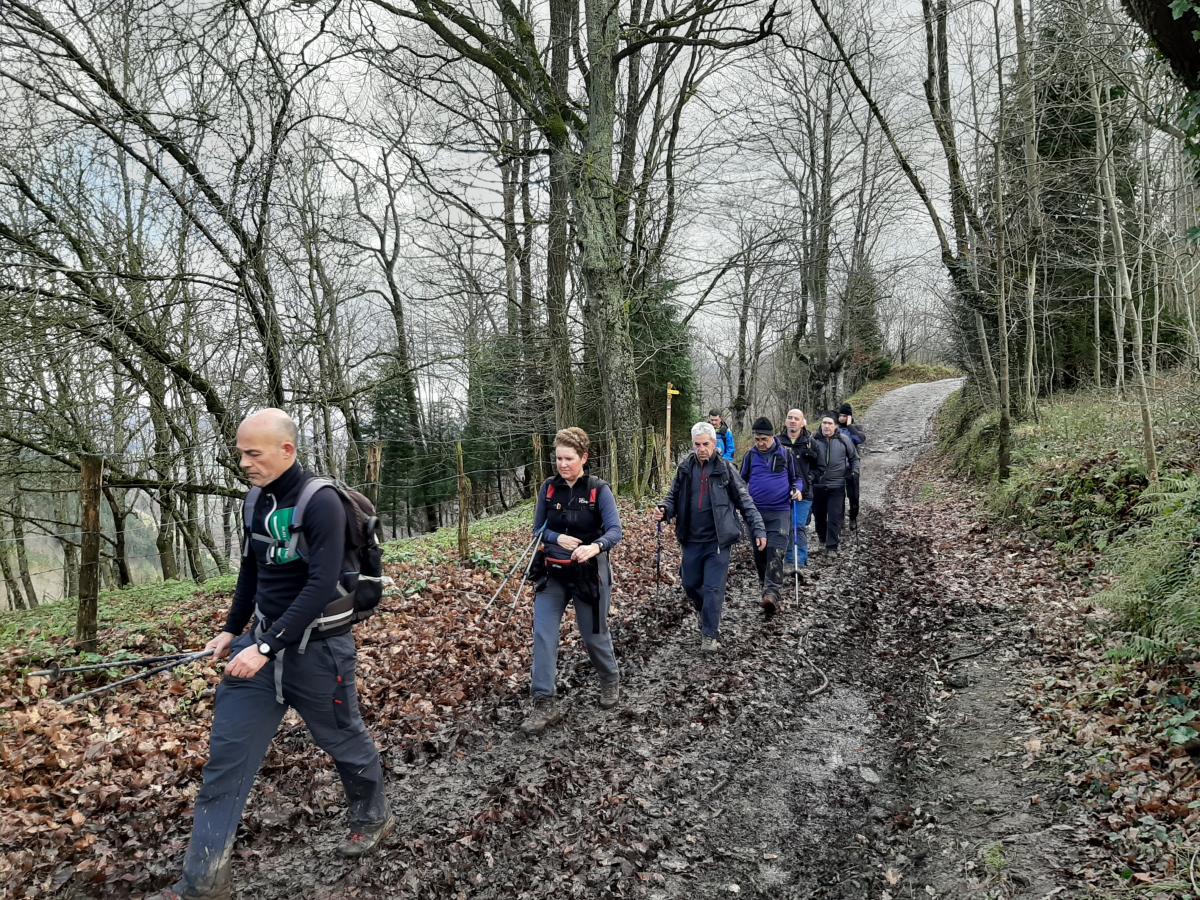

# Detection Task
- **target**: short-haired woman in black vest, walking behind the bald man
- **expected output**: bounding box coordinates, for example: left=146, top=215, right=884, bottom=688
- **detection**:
left=521, top=428, right=622, bottom=734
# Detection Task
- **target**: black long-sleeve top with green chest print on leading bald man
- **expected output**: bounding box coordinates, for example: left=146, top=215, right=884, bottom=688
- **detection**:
left=224, top=463, right=346, bottom=650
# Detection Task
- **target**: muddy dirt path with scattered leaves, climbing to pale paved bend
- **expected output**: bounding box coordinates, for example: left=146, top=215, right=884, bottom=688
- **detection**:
left=194, top=380, right=1089, bottom=900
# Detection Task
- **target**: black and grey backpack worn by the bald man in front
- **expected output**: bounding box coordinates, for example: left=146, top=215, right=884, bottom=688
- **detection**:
left=242, top=476, right=385, bottom=646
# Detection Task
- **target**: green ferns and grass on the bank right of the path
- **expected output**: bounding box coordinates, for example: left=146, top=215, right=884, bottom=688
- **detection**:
left=937, top=382, right=1200, bottom=664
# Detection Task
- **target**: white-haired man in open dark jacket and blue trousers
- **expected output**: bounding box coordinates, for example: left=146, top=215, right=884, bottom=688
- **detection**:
left=658, top=422, right=767, bottom=653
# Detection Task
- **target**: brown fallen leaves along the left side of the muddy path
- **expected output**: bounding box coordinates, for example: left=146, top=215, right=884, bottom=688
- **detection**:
left=0, top=503, right=677, bottom=896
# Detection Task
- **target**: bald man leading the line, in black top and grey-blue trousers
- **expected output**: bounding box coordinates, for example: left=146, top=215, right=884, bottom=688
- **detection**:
left=161, top=409, right=396, bottom=900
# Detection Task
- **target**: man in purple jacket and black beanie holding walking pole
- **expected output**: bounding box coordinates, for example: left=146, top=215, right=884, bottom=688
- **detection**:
left=740, top=416, right=805, bottom=618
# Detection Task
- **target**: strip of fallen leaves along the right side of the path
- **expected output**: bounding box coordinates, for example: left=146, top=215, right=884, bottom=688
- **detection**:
left=892, top=461, right=1200, bottom=895
